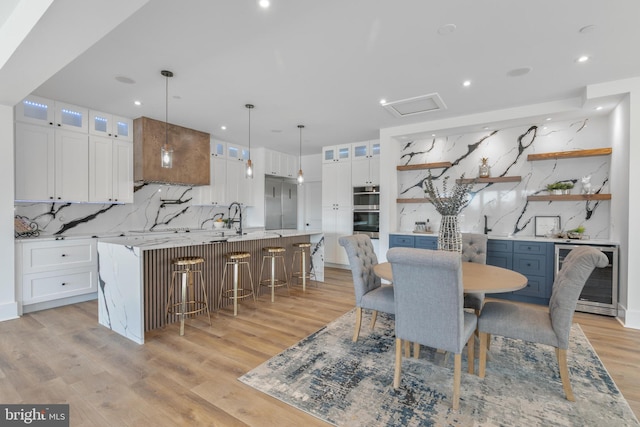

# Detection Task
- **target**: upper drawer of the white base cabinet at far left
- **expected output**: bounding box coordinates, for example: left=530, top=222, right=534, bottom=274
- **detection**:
left=22, top=240, right=96, bottom=274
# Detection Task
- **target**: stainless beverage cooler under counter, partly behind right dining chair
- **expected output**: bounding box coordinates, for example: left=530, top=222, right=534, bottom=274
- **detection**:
left=555, top=244, right=618, bottom=316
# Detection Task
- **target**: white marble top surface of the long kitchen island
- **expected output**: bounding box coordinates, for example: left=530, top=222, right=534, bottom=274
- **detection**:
left=99, top=228, right=322, bottom=250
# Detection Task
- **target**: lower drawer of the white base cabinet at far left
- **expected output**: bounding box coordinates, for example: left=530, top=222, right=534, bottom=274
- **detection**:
left=22, top=270, right=97, bottom=304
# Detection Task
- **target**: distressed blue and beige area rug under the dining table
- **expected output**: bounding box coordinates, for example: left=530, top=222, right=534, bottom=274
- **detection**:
left=239, top=311, right=640, bottom=426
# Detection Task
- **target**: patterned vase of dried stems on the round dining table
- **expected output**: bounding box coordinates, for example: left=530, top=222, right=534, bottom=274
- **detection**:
left=424, top=172, right=475, bottom=252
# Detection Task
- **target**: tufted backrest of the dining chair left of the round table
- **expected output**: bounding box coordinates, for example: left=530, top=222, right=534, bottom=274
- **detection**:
left=338, top=234, right=382, bottom=306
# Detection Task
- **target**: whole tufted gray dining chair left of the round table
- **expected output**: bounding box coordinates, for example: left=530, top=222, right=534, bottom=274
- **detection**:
left=338, top=234, right=395, bottom=342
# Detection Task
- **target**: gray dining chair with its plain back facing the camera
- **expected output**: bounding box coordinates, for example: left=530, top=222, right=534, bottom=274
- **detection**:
left=387, top=248, right=477, bottom=409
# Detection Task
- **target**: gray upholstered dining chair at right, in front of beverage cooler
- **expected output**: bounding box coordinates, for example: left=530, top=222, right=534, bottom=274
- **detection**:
left=478, top=246, right=609, bottom=401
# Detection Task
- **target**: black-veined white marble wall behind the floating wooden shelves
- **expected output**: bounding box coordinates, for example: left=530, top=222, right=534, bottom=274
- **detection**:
left=397, top=117, right=616, bottom=239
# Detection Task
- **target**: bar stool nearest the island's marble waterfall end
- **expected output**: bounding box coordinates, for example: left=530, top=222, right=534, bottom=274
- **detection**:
left=165, top=257, right=211, bottom=336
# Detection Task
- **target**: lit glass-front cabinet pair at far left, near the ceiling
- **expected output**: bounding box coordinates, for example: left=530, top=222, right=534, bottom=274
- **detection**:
left=16, top=96, right=89, bottom=133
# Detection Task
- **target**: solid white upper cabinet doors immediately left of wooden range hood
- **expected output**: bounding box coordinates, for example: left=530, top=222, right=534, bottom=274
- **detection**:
left=89, top=135, right=133, bottom=203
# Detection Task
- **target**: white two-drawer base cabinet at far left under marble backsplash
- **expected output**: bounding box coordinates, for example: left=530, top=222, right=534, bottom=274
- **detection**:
left=16, top=239, right=98, bottom=313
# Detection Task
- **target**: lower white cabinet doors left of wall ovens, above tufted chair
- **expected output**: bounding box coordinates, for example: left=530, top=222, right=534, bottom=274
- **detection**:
left=322, top=206, right=353, bottom=265
